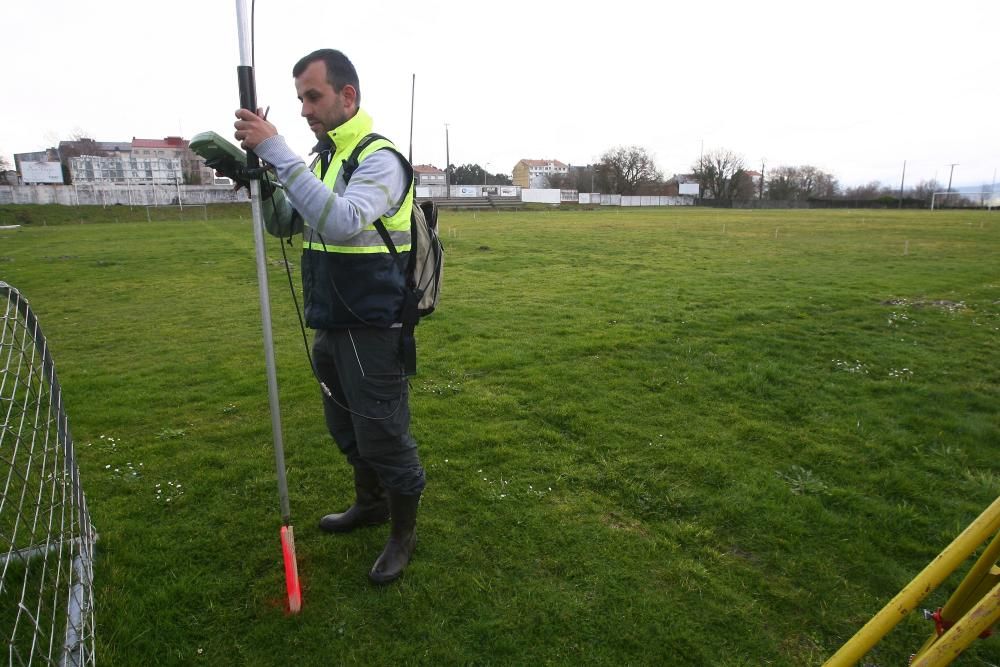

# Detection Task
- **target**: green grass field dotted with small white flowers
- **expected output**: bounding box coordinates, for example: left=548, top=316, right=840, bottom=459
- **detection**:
left=0, top=207, right=1000, bottom=666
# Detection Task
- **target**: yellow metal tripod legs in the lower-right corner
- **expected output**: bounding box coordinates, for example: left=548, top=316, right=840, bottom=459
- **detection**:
left=824, top=498, right=1000, bottom=667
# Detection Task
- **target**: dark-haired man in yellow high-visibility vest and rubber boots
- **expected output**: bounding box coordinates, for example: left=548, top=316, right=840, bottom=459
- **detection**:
left=235, top=49, right=424, bottom=583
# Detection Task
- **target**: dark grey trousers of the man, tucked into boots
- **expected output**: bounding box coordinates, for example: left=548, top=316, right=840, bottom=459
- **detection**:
left=313, top=328, right=425, bottom=495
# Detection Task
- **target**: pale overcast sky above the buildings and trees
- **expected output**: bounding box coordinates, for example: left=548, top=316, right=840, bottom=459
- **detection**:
left=0, top=0, right=1000, bottom=187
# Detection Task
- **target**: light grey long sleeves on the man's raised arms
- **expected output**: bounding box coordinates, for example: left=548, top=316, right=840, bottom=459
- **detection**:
left=256, top=135, right=409, bottom=242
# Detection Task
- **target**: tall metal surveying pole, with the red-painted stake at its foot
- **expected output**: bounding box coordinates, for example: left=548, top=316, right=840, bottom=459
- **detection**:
left=236, top=0, right=302, bottom=614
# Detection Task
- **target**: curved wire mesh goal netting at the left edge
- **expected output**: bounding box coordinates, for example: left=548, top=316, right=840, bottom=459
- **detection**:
left=0, top=282, right=96, bottom=667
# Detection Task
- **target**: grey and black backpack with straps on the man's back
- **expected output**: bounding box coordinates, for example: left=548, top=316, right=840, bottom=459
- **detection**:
left=341, top=133, right=444, bottom=375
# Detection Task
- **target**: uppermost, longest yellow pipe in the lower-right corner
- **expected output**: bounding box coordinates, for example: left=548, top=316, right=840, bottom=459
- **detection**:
left=824, top=498, right=1000, bottom=667
